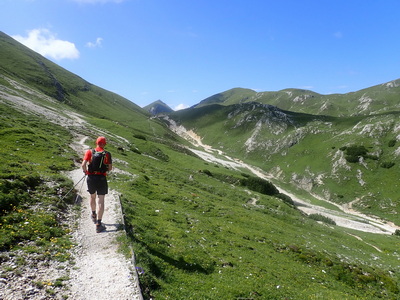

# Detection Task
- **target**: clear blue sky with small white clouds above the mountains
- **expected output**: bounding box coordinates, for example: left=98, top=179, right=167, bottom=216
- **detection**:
left=0, top=0, right=400, bottom=109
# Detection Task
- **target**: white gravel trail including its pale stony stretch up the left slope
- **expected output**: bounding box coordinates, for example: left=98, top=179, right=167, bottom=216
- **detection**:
left=0, top=81, right=143, bottom=300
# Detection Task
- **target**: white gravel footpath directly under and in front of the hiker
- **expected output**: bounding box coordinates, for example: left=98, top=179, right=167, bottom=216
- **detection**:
left=64, top=138, right=143, bottom=300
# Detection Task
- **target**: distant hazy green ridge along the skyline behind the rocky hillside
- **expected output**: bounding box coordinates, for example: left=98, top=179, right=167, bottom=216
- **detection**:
left=197, top=79, right=400, bottom=116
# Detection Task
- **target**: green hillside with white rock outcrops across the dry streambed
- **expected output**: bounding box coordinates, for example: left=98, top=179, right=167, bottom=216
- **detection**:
left=170, top=102, right=400, bottom=225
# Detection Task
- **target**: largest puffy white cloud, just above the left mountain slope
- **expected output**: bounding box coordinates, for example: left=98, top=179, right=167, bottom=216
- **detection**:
left=13, top=29, right=79, bottom=60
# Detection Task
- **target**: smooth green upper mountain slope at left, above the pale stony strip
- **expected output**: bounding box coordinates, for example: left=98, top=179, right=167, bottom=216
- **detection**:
left=0, top=32, right=147, bottom=122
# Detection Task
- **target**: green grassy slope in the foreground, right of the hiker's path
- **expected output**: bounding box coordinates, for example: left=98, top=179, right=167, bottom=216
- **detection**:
left=114, top=137, right=399, bottom=299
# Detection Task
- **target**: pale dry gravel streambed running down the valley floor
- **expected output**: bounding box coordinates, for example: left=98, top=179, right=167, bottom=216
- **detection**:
left=166, top=118, right=400, bottom=234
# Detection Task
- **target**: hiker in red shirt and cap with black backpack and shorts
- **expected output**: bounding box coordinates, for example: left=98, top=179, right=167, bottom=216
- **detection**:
left=82, top=136, right=112, bottom=233
